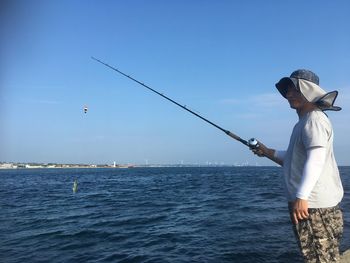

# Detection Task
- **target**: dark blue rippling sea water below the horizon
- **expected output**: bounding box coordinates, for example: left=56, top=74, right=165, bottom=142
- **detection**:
left=0, top=167, right=350, bottom=263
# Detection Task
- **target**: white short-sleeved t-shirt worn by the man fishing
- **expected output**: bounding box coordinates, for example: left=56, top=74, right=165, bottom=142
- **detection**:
left=283, top=110, right=344, bottom=208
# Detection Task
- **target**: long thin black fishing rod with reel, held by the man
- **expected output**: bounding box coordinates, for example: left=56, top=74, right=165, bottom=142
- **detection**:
left=91, top=57, right=280, bottom=164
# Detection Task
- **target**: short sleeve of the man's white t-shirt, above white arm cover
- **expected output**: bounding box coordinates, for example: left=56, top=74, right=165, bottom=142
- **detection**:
left=302, top=118, right=331, bottom=149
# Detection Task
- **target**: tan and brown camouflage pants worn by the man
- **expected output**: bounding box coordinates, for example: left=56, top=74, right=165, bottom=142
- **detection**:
left=290, top=206, right=343, bottom=263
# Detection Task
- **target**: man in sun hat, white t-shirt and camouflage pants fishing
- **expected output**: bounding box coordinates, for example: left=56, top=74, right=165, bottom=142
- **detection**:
left=253, top=70, right=343, bottom=263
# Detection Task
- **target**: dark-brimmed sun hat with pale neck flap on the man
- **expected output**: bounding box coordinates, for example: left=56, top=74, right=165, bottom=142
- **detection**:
left=276, top=69, right=341, bottom=111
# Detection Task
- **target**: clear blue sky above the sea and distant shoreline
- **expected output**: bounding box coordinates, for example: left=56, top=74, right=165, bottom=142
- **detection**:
left=0, top=0, right=350, bottom=165
